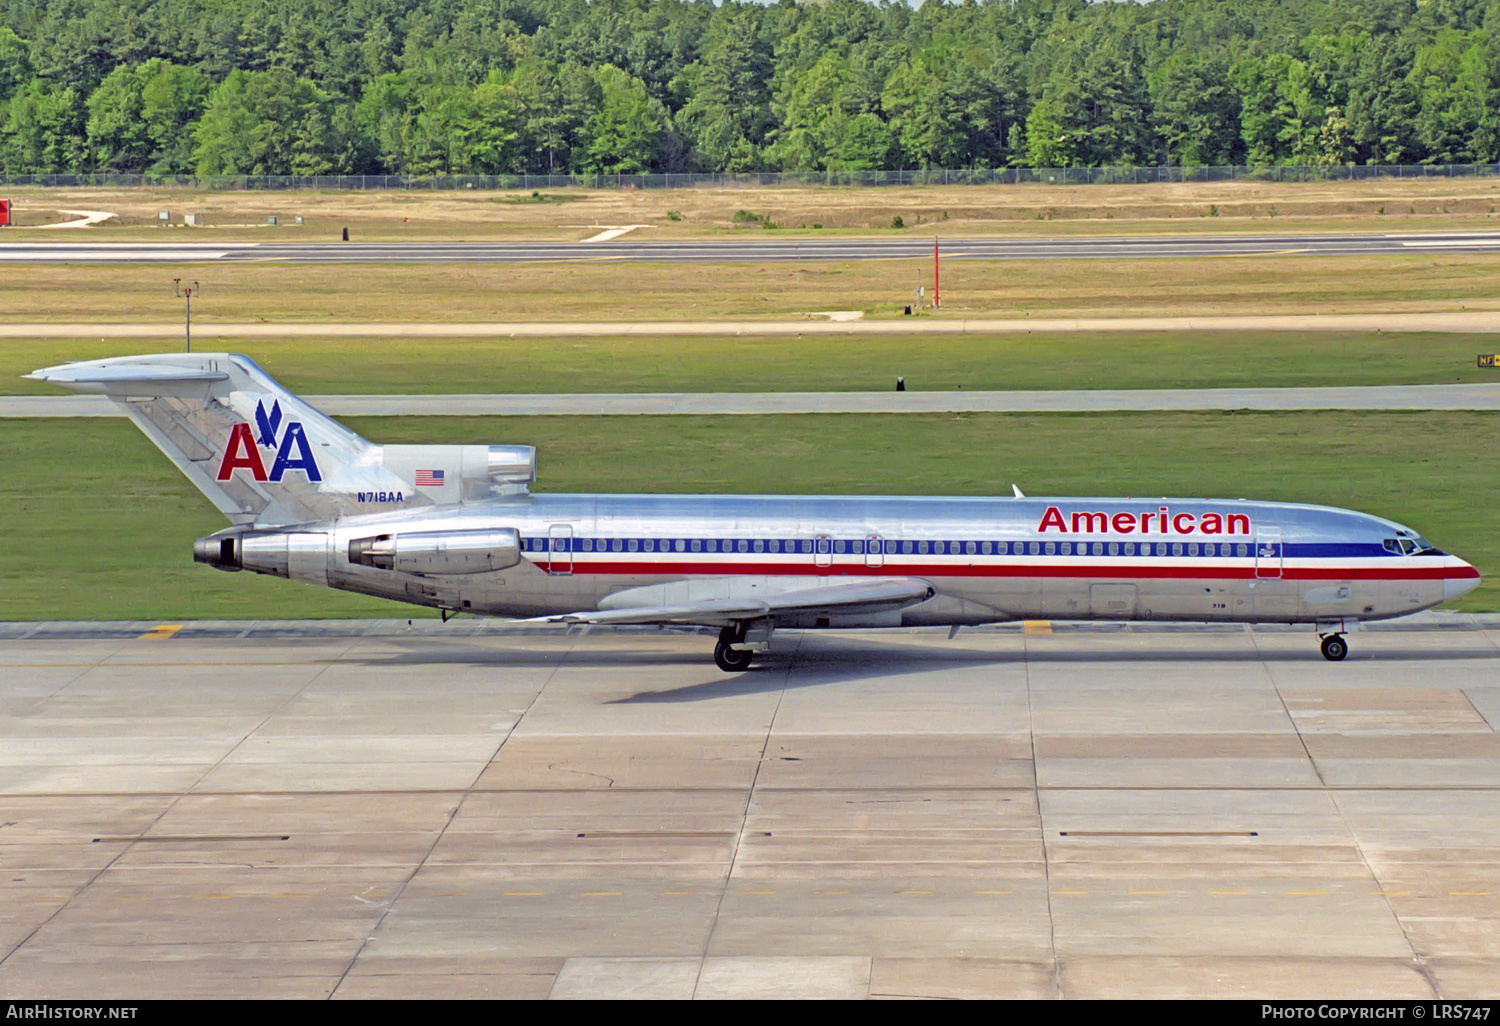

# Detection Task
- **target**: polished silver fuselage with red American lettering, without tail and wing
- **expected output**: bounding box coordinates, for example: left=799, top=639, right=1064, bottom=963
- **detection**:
left=284, top=495, right=1479, bottom=627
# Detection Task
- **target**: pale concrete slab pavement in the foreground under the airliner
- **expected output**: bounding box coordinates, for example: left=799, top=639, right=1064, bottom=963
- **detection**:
left=0, top=615, right=1500, bottom=999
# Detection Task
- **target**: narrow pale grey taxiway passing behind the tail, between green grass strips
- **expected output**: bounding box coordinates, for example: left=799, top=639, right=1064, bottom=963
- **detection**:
left=0, top=383, right=1500, bottom=419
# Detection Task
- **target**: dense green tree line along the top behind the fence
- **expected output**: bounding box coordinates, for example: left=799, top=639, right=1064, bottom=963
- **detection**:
left=0, top=0, right=1500, bottom=174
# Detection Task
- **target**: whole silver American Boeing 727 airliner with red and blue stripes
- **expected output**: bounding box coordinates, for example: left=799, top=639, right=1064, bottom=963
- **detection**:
left=30, top=354, right=1479, bottom=671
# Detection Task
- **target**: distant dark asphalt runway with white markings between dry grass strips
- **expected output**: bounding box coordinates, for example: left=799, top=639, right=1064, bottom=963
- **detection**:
left=0, top=231, right=1500, bottom=264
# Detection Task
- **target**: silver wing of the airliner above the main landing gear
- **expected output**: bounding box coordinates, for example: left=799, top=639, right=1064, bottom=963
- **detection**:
left=539, top=578, right=933, bottom=626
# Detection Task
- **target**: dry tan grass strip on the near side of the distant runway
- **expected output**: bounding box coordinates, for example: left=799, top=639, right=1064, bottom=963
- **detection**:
left=0, top=254, right=1500, bottom=324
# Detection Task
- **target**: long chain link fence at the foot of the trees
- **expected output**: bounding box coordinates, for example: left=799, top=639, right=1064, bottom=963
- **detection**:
left=0, top=164, right=1500, bottom=191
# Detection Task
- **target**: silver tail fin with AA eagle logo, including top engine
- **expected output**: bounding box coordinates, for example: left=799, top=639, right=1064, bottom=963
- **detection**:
left=27, top=353, right=536, bottom=527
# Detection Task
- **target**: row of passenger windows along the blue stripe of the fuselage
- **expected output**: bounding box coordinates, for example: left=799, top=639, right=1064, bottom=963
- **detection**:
left=521, top=537, right=1274, bottom=557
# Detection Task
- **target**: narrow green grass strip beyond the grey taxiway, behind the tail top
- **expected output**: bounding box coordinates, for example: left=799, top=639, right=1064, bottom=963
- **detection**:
left=0, top=332, right=1500, bottom=395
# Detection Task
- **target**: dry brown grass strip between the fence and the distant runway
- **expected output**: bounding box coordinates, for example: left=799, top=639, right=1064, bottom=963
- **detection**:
left=3, top=179, right=1500, bottom=242
